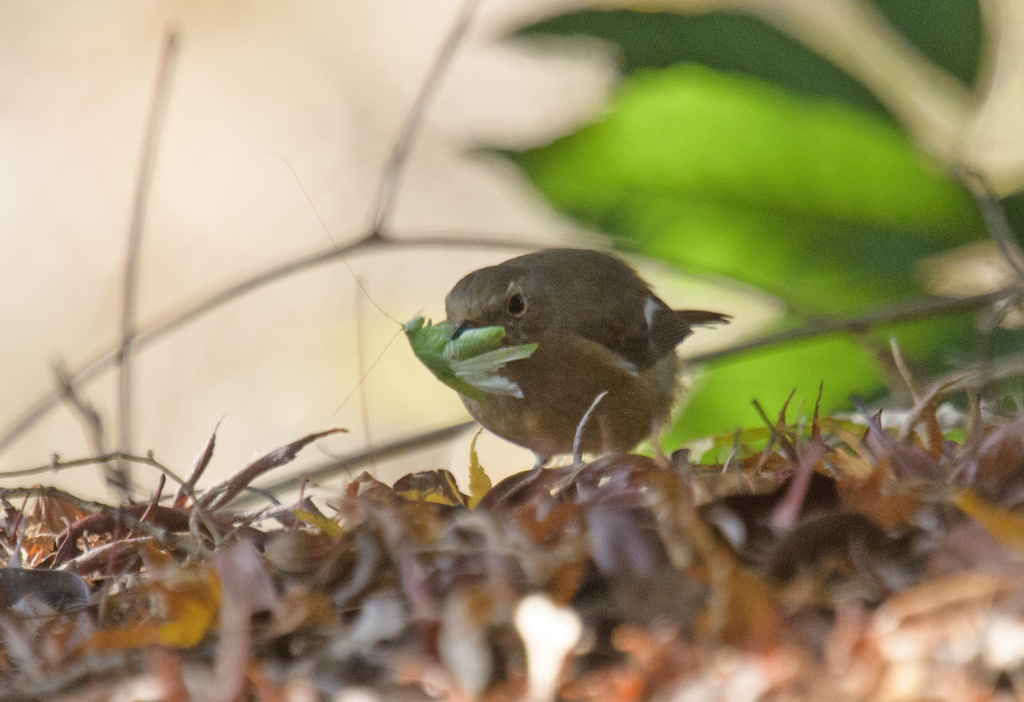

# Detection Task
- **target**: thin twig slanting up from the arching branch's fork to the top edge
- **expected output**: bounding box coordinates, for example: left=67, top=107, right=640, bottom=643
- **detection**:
left=370, top=0, right=478, bottom=237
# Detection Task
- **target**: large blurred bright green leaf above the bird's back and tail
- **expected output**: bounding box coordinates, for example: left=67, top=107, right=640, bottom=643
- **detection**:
left=514, top=65, right=983, bottom=314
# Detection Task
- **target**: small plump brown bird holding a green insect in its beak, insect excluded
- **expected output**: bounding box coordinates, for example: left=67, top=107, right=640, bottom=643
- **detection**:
left=444, top=249, right=729, bottom=465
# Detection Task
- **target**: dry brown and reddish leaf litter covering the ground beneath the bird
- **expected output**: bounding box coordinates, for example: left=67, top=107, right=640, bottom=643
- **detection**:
left=0, top=407, right=1024, bottom=702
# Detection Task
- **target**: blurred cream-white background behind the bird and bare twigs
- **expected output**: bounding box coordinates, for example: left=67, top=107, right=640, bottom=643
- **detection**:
left=0, top=0, right=767, bottom=499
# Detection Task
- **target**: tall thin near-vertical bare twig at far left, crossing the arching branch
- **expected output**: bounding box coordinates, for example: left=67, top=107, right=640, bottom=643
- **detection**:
left=113, top=32, right=178, bottom=497
